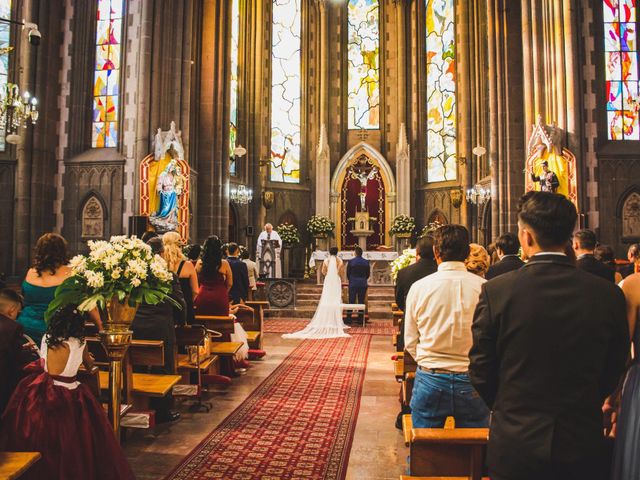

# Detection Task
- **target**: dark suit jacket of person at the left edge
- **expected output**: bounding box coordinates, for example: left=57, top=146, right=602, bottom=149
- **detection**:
left=0, top=315, right=31, bottom=416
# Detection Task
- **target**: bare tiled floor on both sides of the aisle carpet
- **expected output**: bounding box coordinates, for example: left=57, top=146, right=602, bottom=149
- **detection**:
left=124, top=334, right=408, bottom=480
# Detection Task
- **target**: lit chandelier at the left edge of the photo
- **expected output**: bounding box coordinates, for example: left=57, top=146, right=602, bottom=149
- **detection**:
left=0, top=83, right=39, bottom=144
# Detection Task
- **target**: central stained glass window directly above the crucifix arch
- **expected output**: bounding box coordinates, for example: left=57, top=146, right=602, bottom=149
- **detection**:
left=347, top=0, right=380, bottom=130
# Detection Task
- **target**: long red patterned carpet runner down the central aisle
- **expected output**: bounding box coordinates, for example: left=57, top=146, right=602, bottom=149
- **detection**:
left=167, top=335, right=371, bottom=480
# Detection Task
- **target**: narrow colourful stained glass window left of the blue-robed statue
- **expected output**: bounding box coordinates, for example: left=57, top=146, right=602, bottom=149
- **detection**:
left=91, top=0, right=123, bottom=148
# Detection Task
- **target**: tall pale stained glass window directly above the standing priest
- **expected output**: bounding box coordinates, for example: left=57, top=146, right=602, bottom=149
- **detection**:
left=270, top=0, right=302, bottom=183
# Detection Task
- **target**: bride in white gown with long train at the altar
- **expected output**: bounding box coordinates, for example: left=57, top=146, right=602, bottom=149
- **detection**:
left=282, top=247, right=350, bottom=339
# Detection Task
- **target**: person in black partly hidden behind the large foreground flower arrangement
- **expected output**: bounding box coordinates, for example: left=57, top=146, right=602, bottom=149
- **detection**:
left=131, top=237, right=187, bottom=422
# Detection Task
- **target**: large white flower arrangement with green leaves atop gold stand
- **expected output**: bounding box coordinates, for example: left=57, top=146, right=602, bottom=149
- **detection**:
left=45, top=235, right=179, bottom=319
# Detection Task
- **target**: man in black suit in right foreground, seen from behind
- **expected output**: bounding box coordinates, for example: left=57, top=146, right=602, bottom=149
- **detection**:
left=469, top=192, right=629, bottom=480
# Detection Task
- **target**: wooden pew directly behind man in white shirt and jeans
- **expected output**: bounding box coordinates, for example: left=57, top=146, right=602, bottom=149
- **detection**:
left=402, top=415, right=489, bottom=480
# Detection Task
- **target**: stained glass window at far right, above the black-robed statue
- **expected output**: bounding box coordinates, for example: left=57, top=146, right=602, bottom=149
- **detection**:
left=603, top=0, right=640, bottom=140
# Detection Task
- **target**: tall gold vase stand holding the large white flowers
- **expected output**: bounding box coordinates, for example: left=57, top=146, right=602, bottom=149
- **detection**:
left=99, top=296, right=138, bottom=440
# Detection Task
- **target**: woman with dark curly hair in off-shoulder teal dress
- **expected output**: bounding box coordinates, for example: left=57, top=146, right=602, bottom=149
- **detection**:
left=18, top=233, right=71, bottom=345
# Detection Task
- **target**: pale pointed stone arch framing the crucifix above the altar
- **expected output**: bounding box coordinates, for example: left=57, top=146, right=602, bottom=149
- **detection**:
left=330, top=142, right=397, bottom=245
